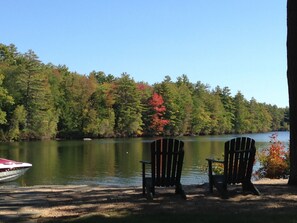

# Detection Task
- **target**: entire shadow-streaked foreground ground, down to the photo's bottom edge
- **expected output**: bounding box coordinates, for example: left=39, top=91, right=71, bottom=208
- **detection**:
left=0, top=184, right=297, bottom=223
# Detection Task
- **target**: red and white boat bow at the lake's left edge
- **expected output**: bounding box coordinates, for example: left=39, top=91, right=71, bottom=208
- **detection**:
left=0, top=158, right=32, bottom=183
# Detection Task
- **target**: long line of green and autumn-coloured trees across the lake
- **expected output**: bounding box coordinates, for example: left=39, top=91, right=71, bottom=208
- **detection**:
left=0, top=44, right=288, bottom=141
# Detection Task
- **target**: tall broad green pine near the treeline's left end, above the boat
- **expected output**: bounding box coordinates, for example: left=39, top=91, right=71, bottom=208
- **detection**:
left=7, top=50, right=57, bottom=139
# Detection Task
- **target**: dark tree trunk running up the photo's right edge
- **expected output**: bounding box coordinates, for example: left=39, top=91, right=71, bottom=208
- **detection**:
left=287, top=0, right=297, bottom=185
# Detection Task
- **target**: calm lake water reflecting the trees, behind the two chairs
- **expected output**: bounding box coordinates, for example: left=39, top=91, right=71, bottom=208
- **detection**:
left=0, top=132, right=289, bottom=186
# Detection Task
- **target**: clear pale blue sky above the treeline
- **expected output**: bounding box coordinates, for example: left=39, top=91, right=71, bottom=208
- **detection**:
left=0, top=0, right=288, bottom=107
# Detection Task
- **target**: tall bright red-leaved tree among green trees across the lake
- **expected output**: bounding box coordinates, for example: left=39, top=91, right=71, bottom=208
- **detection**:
left=149, top=93, right=169, bottom=135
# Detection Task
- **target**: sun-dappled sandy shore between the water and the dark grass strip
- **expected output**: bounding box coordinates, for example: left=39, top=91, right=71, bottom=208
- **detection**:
left=0, top=179, right=297, bottom=222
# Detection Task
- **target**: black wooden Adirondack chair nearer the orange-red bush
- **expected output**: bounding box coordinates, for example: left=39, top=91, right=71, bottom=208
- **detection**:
left=206, top=137, right=260, bottom=198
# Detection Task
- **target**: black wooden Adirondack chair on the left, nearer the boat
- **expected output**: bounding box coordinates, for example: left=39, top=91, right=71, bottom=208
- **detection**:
left=140, top=138, right=186, bottom=199
